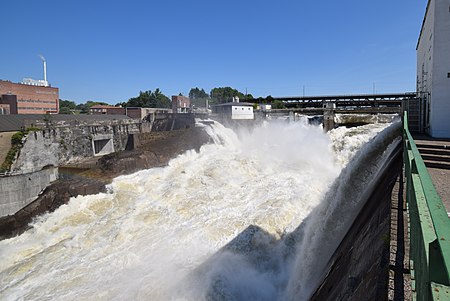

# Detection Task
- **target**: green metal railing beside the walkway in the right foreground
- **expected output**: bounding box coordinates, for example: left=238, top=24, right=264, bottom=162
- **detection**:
left=403, top=112, right=450, bottom=300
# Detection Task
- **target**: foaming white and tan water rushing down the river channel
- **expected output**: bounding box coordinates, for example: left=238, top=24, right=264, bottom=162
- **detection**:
left=0, top=118, right=400, bottom=300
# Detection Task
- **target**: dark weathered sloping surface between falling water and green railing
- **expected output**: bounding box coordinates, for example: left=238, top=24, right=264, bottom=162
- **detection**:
left=311, top=141, right=402, bottom=301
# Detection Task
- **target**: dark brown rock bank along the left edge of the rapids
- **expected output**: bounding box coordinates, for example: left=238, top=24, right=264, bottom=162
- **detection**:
left=0, top=127, right=209, bottom=239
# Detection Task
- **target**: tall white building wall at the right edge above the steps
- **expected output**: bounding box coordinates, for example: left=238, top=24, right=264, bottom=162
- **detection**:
left=416, top=0, right=450, bottom=138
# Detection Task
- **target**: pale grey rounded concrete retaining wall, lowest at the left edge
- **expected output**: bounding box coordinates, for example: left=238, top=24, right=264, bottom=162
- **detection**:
left=0, top=168, right=58, bottom=216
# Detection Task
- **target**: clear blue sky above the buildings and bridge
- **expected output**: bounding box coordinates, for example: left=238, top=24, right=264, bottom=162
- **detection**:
left=0, top=0, right=427, bottom=104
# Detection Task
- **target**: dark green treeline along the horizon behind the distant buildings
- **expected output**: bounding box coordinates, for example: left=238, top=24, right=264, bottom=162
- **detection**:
left=59, top=87, right=284, bottom=114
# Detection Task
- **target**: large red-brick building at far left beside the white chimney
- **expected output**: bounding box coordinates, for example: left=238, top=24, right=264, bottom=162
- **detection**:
left=0, top=80, right=59, bottom=114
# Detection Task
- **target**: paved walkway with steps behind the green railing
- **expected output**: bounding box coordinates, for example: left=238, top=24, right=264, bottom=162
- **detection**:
left=413, top=135, right=450, bottom=212
